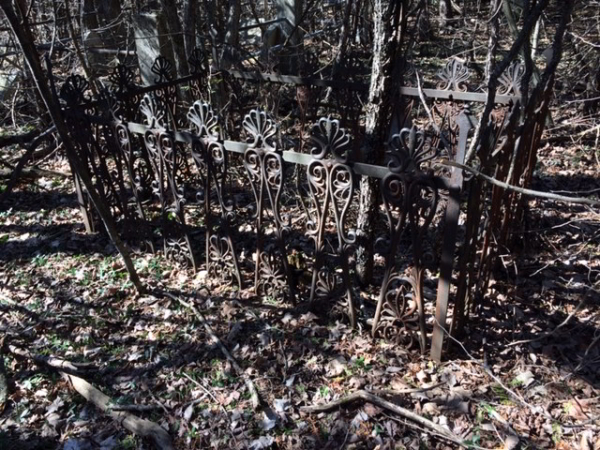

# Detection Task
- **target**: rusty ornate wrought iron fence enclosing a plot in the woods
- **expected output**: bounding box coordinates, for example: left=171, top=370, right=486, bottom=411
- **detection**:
left=61, top=55, right=522, bottom=359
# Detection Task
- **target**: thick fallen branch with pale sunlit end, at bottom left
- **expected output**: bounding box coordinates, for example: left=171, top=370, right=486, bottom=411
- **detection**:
left=62, top=372, right=175, bottom=450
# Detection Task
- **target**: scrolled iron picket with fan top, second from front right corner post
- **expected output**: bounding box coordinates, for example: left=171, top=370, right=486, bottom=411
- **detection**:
left=306, top=118, right=356, bottom=326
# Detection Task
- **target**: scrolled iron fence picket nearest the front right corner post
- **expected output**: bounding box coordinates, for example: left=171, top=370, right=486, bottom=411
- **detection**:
left=372, top=127, right=438, bottom=352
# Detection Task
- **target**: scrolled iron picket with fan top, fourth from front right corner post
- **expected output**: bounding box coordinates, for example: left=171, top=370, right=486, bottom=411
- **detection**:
left=187, top=101, right=242, bottom=288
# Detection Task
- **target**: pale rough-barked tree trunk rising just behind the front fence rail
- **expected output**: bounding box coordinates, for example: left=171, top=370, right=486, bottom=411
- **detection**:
left=356, top=0, right=407, bottom=285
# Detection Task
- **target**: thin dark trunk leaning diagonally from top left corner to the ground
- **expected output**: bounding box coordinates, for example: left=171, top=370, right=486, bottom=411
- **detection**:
left=0, top=0, right=144, bottom=292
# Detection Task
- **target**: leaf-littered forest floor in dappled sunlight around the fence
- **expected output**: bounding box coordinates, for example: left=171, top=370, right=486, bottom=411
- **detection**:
left=0, top=112, right=600, bottom=450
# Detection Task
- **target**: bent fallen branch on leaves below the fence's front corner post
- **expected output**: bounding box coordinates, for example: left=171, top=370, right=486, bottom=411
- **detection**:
left=300, top=390, right=467, bottom=447
